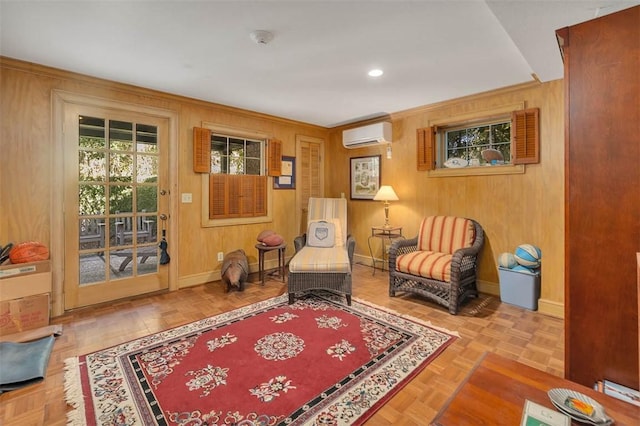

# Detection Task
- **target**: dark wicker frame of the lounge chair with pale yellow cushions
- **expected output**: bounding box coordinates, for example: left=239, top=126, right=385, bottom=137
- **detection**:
left=288, top=234, right=356, bottom=306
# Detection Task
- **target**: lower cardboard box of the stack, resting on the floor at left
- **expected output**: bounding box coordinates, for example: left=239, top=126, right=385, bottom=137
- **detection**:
left=0, top=294, right=49, bottom=335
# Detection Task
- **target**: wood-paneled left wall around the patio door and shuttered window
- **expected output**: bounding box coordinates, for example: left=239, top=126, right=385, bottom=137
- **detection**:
left=0, top=58, right=328, bottom=314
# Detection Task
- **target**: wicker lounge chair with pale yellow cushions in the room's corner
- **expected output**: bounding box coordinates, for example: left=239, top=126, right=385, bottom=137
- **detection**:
left=288, top=198, right=356, bottom=305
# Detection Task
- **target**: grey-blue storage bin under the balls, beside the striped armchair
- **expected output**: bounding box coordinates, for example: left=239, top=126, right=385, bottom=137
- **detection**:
left=498, top=267, right=540, bottom=311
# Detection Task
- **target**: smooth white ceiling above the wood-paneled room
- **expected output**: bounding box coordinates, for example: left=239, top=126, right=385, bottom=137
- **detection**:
left=0, top=0, right=640, bottom=127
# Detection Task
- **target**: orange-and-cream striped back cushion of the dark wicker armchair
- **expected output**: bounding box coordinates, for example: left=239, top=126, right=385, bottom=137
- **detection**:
left=418, top=216, right=475, bottom=254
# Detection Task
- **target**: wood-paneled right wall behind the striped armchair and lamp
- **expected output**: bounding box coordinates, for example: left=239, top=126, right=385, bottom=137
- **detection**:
left=326, top=80, right=564, bottom=317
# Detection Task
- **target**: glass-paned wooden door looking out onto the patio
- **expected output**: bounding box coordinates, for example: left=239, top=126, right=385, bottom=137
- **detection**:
left=64, top=109, right=168, bottom=309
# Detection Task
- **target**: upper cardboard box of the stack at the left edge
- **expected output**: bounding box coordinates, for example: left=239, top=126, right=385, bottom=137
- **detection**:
left=0, top=260, right=51, bottom=301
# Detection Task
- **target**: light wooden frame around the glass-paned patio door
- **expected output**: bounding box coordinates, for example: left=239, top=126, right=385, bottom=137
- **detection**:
left=50, top=90, right=179, bottom=316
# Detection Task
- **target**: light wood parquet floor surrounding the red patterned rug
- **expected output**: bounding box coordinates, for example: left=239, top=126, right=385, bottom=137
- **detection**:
left=0, top=265, right=564, bottom=426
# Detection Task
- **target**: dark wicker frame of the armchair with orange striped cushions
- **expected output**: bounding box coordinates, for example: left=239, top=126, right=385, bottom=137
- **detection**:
left=389, top=219, right=484, bottom=315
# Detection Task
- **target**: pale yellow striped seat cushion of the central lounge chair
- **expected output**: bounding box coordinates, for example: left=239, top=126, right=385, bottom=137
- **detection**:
left=289, top=246, right=351, bottom=273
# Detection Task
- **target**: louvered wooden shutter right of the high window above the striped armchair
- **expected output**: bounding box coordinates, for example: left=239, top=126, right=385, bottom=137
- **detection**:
left=511, top=108, right=540, bottom=164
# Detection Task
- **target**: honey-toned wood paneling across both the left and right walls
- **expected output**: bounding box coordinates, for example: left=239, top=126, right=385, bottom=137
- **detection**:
left=0, top=58, right=564, bottom=316
